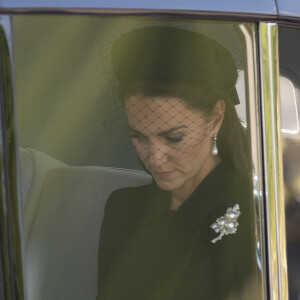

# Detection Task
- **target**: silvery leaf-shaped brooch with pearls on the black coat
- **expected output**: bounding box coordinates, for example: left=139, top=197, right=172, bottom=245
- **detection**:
left=210, top=204, right=241, bottom=243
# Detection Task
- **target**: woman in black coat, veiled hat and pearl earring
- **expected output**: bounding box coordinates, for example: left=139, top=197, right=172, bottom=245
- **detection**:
left=98, top=27, right=258, bottom=300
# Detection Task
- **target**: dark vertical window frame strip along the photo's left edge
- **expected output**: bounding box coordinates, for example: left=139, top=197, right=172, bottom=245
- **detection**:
left=0, top=16, right=25, bottom=300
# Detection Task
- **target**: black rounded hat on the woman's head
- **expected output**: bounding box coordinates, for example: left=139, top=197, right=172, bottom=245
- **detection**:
left=111, top=26, right=239, bottom=104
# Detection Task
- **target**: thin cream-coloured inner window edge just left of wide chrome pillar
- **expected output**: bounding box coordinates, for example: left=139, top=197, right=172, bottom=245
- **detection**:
left=239, top=24, right=267, bottom=299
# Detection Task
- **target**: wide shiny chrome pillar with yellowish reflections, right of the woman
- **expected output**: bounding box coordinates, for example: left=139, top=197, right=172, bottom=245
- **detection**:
left=259, top=23, right=288, bottom=300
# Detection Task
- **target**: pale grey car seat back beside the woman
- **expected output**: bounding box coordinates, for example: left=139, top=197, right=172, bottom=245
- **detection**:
left=19, top=149, right=152, bottom=300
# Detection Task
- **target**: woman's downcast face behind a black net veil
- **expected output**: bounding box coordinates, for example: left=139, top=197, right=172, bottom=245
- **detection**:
left=125, top=96, right=224, bottom=192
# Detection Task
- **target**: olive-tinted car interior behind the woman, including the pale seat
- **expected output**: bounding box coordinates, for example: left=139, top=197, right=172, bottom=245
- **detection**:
left=12, top=15, right=300, bottom=300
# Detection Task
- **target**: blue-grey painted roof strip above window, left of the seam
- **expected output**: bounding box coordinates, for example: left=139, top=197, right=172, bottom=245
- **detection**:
left=0, top=0, right=278, bottom=16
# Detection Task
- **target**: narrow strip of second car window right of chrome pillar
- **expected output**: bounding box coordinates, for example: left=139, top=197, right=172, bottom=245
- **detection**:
left=279, top=27, right=300, bottom=300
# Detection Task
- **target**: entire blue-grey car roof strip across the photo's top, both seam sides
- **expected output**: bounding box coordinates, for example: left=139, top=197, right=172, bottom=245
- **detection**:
left=0, top=0, right=300, bottom=18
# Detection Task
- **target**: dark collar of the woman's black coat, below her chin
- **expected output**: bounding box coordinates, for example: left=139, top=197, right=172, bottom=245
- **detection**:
left=139, top=162, right=236, bottom=227
